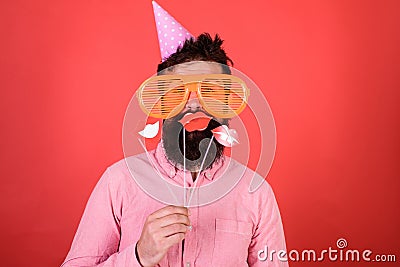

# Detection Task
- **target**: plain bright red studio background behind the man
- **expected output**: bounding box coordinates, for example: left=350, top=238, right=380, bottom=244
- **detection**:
left=0, top=0, right=400, bottom=266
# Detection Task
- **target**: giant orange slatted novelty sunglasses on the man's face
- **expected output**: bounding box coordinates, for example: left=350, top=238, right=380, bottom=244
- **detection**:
left=137, top=74, right=249, bottom=119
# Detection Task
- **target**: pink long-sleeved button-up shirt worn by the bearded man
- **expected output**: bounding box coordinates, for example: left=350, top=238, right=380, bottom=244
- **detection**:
left=62, top=145, right=288, bottom=267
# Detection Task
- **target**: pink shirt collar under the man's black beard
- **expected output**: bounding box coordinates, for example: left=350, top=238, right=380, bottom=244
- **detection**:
left=153, top=142, right=225, bottom=181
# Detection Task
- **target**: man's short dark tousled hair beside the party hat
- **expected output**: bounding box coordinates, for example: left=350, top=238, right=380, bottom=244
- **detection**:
left=157, top=33, right=233, bottom=74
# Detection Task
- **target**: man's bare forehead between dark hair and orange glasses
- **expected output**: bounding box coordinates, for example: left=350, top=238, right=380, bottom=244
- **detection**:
left=164, top=61, right=222, bottom=75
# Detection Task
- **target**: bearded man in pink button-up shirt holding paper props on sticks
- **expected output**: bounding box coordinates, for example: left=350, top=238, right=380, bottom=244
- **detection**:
left=62, top=34, right=287, bottom=267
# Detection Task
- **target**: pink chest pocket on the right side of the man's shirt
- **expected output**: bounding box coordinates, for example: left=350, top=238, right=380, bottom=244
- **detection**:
left=212, top=219, right=253, bottom=267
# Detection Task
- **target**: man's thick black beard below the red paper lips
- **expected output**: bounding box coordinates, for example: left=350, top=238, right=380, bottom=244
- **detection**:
left=162, top=119, right=227, bottom=172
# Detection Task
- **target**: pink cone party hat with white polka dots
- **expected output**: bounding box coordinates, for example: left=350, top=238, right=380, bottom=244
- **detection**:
left=152, top=1, right=193, bottom=60
